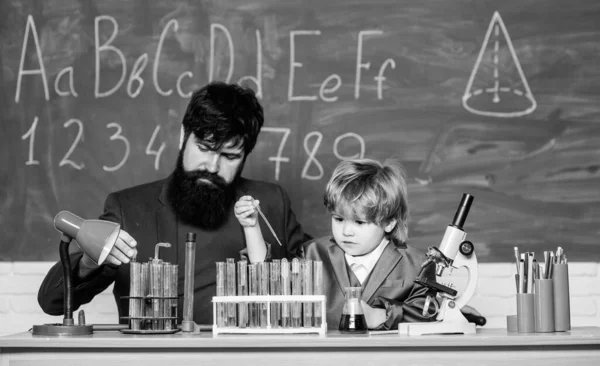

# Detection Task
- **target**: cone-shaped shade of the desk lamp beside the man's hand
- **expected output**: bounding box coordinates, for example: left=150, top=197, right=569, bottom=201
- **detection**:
left=54, top=211, right=121, bottom=265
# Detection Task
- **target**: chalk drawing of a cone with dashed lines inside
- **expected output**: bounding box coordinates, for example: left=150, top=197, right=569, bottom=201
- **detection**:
left=462, top=12, right=537, bottom=118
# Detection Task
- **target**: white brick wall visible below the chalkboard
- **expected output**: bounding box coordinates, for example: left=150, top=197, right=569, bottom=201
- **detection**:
left=0, top=262, right=600, bottom=336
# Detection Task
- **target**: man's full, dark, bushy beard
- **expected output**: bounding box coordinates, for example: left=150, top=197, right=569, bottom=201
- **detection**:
left=167, top=154, right=241, bottom=230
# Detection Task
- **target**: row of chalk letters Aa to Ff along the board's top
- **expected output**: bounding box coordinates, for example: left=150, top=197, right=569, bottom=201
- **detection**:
left=15, top=15, right=396, bottom=103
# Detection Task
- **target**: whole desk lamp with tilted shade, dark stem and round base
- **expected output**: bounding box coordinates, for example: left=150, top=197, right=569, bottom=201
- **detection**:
left=33, top=211, right=121, bottom=335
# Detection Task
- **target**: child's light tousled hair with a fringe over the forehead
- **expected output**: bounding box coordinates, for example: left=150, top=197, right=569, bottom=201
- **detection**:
left=324, top=159, right=408, bottom=242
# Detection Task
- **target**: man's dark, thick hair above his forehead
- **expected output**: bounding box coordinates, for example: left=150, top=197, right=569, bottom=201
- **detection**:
left=183, top=82, right=264, bottom=156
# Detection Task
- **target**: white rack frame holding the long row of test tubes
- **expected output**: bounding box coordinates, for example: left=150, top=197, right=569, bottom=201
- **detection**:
left=212, top=295, right=327, bottom=336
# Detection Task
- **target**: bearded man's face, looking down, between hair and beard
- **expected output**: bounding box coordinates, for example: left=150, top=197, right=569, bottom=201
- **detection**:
left=183, top=133, right=244, bottom=185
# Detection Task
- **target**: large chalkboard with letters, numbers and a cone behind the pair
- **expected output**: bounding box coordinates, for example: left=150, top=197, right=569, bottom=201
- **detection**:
left=0, top=0, right=600, bottom=262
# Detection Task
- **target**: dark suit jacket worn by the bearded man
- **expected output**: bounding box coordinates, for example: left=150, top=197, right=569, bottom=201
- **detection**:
left=38, top=177, right=310, bottom=324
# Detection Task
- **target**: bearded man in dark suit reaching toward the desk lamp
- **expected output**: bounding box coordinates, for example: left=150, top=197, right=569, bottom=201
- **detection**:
left=38, top=82, right=310, bottom=324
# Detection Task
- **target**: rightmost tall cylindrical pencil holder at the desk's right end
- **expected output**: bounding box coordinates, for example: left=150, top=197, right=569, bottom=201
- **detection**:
left=552, top=263, right=571, bottom=332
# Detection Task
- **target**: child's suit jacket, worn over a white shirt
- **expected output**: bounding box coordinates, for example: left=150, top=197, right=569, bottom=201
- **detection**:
left=301, top=237, right=435, bottom=330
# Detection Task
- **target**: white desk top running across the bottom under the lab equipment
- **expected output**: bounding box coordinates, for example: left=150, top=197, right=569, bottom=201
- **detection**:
left=0, top=327, right=600, bottom=352
